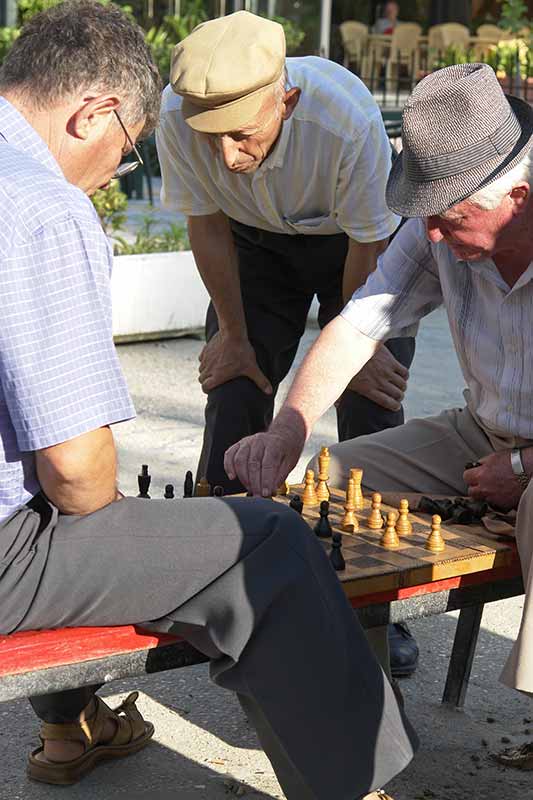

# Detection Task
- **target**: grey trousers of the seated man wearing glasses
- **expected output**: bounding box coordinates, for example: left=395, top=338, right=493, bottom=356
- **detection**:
left=0, top=498, right=416, bottom=800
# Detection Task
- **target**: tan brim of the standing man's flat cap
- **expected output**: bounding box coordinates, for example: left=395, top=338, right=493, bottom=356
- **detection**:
left=181, top=81, right=277, bottom=133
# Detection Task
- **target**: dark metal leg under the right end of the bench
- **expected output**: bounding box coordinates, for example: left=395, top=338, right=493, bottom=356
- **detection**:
left=442, top=603, right=484, bottom=708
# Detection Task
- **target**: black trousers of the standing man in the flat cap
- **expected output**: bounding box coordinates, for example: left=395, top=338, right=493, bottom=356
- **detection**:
left=198, top=221, right=415, bottom=494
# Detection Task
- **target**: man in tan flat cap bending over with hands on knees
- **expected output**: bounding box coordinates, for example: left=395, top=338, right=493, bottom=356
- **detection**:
left=156, top=11, right=417, bottom=671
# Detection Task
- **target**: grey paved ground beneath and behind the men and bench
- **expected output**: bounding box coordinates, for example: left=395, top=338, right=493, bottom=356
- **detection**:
left=0, top=312, right=533, bottom=800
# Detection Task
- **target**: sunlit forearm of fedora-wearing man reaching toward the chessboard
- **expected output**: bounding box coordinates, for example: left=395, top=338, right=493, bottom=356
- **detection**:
left=270, top=316, right=380, bottom=447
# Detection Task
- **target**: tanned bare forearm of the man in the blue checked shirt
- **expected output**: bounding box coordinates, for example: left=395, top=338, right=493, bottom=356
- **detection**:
left=35, top=427, right=120, bottom=514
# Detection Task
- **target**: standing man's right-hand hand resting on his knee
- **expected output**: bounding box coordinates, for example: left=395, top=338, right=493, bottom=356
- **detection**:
left=342, top=347, right=409, bottom=411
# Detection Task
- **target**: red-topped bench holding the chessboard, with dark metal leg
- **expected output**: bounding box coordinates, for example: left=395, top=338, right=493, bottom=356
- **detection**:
left=0, top=546, right=523, bottom=707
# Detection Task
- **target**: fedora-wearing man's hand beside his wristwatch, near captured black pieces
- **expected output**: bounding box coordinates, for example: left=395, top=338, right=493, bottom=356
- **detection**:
left=463, top=450, right=522, bottom=511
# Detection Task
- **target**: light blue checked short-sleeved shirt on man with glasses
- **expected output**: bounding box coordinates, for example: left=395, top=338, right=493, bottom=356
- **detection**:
left=0, top=97, right=135, bottom=521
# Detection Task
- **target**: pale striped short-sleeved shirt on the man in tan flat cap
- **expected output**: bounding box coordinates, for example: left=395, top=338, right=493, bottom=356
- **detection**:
left=156, top=56, right=399, bottom=242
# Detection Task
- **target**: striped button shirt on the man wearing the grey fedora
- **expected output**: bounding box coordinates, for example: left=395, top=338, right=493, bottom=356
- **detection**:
left=342, top=219, right=533, bottom=440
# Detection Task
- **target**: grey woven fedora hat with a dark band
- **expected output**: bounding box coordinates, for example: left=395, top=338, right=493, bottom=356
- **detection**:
left=387, top=64, right=533, bottom=217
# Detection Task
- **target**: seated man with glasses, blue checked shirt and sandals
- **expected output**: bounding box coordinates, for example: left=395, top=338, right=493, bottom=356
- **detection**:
left=0, top=0, right=414, bottom=800
